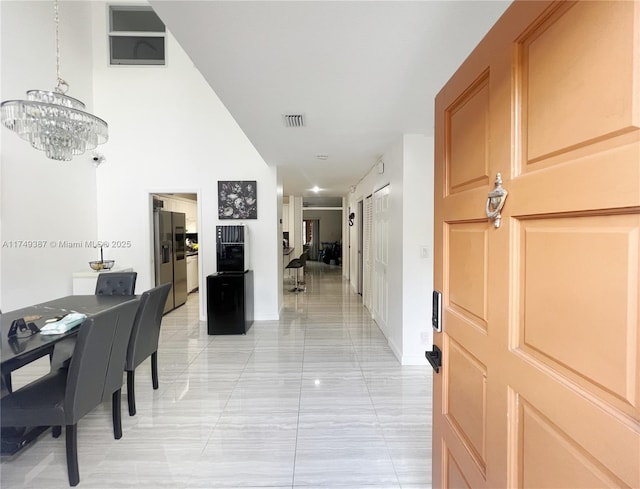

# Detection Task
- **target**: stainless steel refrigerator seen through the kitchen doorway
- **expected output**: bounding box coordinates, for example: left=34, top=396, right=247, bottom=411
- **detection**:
left=153, top=209, right=187, bottom=313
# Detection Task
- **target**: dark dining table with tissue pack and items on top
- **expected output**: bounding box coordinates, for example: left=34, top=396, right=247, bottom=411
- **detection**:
left=0, top=295, right=140, bottom=455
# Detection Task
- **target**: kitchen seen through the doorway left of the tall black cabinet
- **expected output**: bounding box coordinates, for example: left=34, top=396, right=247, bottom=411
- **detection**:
left=152, top=193, right=200, bottom=312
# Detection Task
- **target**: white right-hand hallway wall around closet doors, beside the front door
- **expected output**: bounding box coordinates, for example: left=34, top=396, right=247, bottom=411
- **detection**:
left=348, top=134, right=433, bottom=365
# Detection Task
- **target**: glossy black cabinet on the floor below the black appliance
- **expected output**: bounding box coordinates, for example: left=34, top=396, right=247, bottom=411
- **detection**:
left=207, top=270, right=253, bottom=335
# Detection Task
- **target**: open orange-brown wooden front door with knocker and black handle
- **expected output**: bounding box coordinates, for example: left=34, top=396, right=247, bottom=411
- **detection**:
left=433, top=1, right=640, bottom=489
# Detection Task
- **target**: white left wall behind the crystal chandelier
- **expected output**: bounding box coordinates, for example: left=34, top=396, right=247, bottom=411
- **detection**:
left=0, top=1, right=102, bottom=311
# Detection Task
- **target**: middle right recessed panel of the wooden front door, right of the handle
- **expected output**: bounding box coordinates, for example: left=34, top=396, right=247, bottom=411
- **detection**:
left=515, top=214, right=640, bottom=407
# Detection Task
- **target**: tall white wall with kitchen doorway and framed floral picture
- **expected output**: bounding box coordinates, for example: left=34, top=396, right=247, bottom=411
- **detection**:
left=91, top=2, right=281, bottom=320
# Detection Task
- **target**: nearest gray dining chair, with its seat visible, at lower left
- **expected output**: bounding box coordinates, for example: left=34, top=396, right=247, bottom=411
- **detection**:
left=0, top=301, right=138, bottom=486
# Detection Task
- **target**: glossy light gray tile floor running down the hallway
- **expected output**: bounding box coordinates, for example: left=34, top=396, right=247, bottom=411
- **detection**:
left=0, top=263, right=431, bottom=489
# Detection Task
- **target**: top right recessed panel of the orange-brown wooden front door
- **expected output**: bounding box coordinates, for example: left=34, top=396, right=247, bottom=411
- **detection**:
left=514, top=2, right=640, bottom=165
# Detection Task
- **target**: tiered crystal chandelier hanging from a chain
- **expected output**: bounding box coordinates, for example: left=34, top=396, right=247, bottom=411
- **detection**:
left=0, top=0, right=109, bottom=161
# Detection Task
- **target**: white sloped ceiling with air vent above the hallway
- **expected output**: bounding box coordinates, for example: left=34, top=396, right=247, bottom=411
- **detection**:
left=150, top=0, right=509, bottom=196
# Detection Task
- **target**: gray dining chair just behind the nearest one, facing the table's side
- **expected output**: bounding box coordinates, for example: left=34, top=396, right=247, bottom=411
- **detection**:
left=125, top=283, right=171, bottom=416
